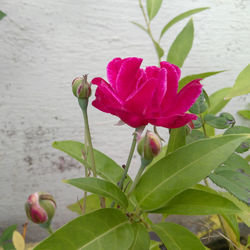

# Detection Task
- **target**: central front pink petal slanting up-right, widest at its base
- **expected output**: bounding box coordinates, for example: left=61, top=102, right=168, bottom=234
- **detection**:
left=124, top=78, right=158, bottom=115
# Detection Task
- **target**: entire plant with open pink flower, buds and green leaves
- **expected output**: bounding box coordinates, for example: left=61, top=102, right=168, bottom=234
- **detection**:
left=23, top=0, right=250, bottom=250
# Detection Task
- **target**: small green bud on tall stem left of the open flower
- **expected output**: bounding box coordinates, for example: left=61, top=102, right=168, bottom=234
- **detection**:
left=72, top=75, right=91, bottom=99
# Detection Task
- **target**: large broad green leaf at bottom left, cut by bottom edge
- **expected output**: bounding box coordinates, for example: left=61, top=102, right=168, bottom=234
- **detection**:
left=34, top=208, right=134, bottom=250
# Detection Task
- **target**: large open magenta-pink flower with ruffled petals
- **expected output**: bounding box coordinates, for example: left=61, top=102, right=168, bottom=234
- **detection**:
left=92, top=57, right=202, bottom=128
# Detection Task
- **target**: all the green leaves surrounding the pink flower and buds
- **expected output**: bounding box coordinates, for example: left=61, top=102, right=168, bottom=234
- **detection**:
left=27, top=0, right=250, bottom=250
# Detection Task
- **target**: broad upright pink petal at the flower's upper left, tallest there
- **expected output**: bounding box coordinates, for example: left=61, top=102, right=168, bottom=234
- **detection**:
left=116, top=57, right=142, bottom=100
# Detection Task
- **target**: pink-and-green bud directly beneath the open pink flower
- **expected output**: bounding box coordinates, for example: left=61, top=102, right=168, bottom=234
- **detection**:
left=137, top=131, right=161, bottom=161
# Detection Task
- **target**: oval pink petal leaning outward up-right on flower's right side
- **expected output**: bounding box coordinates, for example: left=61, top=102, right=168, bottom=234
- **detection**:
left=173, top=79, right=202, bottom=113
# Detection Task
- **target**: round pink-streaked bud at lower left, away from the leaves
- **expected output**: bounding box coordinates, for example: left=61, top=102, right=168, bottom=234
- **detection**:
left=25, top=192, right=56, bottom=225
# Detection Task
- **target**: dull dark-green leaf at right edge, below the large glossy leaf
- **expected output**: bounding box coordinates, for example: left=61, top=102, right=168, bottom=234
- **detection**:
left=209, top=170, right=250, bottom=205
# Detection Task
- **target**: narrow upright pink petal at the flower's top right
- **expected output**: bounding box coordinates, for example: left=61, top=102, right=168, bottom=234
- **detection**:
left=160, top=62, right=180, bottom=110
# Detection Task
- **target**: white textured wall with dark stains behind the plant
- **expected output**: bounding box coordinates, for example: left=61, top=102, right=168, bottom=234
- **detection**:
left=0, top=0, right=250, bottom=242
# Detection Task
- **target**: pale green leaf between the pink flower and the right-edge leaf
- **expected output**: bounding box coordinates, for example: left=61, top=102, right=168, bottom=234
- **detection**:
left=207, top=88, right=232, bottom=115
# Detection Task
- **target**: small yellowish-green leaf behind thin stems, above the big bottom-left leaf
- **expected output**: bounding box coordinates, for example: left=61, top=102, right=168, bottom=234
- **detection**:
left=67, top=194, right=112, bottom=215
